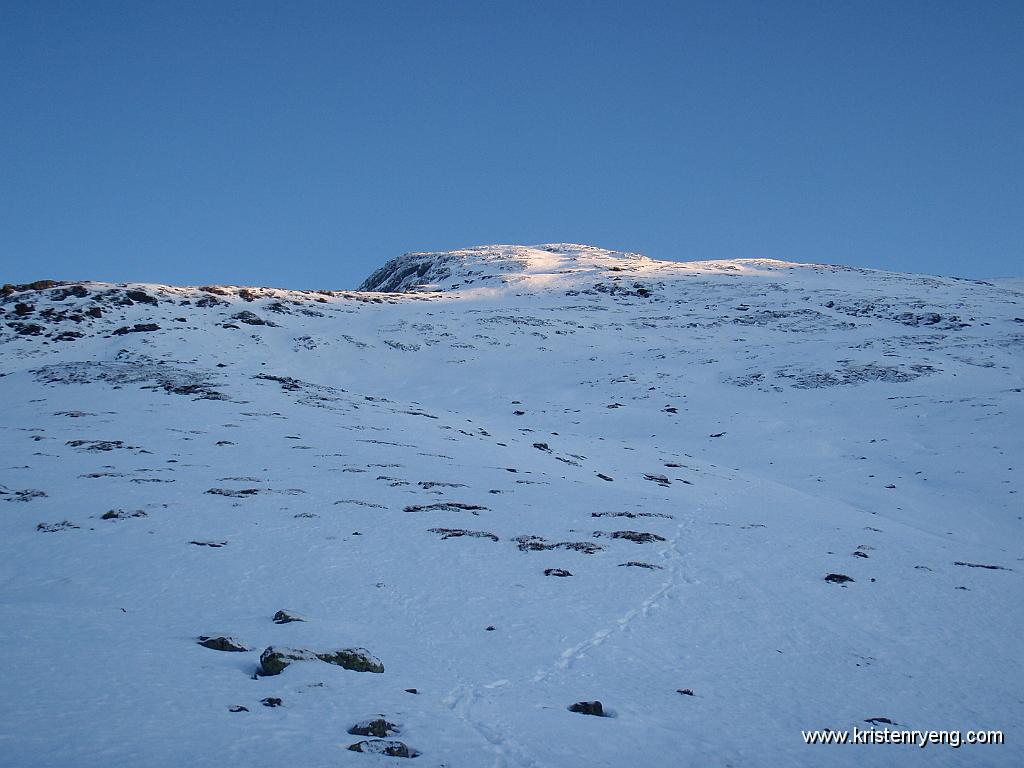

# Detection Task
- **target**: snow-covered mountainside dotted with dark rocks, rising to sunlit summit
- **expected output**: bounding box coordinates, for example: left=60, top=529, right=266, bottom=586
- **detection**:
left=0, top=245, right=1024, bottom=768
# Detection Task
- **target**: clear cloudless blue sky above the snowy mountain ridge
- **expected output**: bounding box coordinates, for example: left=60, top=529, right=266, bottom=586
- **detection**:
left=0, top=0, right=1024, bottom=288
